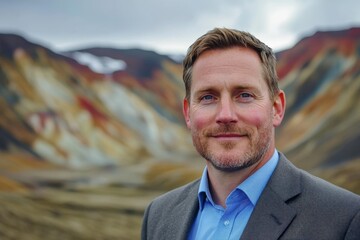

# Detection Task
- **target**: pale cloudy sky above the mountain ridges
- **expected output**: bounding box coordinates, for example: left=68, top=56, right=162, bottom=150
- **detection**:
left=0, top=0, right=360, bottom=54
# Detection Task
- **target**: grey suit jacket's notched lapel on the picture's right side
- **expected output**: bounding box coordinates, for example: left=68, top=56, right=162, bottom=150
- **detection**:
left=241, top=154, right=301, bottom=240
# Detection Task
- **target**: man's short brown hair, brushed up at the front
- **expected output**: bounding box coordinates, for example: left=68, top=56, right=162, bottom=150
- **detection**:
left=183, top=28, right=279, bottom=100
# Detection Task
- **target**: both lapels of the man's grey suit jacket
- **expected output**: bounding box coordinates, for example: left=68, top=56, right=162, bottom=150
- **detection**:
left=173, top=153, right=302, bottom=240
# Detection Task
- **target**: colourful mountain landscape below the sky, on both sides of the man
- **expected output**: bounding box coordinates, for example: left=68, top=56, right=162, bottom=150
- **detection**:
left=0, top=28, right=360, bottom=239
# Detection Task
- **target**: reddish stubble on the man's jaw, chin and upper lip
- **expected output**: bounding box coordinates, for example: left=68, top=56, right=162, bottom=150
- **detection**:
left=192, top=125, right=272, bottom=172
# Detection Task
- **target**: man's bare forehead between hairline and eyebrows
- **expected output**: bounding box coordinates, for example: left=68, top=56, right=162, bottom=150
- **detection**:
left=192, top=47, right=266, bottom=90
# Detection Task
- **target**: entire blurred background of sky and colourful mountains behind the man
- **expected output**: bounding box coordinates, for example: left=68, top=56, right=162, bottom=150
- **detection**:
left=0, top=0, right=360, bottom=240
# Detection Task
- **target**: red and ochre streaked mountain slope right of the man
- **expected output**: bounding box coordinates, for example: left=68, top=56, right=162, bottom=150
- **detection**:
left=277, top=28, right=360, bottom=192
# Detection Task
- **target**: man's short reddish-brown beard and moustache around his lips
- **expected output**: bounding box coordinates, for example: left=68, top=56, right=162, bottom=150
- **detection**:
left=192, top=122, right=273, bottom=172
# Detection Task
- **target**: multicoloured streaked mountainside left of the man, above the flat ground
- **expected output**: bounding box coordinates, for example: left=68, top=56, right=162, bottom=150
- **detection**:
left=0, top=35, right=197, bottom=168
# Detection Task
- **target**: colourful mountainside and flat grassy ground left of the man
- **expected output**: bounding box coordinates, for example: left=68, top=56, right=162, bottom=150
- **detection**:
left=0, top=34, right=201, bottom=239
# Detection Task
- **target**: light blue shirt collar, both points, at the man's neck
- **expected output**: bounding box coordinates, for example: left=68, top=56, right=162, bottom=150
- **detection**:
left=198, top=149, right=279, bottom=210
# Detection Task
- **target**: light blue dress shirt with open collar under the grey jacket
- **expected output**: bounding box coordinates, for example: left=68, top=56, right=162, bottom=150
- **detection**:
left=188, top=150, right=279, bottom=240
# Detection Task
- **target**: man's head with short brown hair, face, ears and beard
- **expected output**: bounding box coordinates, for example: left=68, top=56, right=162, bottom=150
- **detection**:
left=183, top=29, right=285, bottom=172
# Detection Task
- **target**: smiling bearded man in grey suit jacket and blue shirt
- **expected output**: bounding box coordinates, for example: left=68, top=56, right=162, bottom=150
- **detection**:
left=142, top=28, right=360, bottom=240
